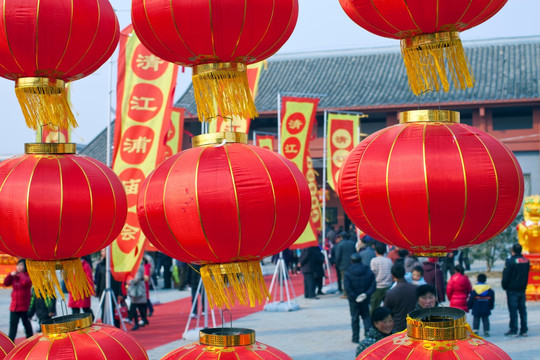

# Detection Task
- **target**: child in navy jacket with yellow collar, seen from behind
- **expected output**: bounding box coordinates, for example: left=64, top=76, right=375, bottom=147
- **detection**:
left=468, top=274, right=495, bottom=336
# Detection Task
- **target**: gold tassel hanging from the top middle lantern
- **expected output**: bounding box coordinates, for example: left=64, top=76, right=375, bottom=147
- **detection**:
left=192, top=63, right=258, bottom=122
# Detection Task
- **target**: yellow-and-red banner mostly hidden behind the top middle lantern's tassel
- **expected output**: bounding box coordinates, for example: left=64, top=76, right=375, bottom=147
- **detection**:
left=208, top=61, right=266, bottom=134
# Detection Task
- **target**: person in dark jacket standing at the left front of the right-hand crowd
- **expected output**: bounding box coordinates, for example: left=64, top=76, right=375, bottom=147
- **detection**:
left=344, top=253, right=375, bottom=343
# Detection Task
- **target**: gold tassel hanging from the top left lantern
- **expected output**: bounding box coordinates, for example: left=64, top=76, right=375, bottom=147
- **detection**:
left=15, top=77, right=78, bottom=130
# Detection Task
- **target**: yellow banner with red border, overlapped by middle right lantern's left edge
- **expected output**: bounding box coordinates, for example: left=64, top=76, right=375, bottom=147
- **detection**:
left=326, top=113, right=360, bottom=191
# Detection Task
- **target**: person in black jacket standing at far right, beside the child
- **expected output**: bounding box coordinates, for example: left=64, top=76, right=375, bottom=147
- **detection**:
left=501, top=244, right=531, bottom=336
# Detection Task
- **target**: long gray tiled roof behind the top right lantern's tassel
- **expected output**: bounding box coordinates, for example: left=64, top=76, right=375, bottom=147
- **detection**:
left=176, top=37, right=540, bottom=114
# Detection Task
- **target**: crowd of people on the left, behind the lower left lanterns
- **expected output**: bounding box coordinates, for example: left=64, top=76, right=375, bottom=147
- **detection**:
left=4, top=249, right=181, bottom=340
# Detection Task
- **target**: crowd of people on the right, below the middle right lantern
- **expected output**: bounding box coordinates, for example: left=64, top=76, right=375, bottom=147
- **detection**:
left=310, top=228, right=530, bottom=354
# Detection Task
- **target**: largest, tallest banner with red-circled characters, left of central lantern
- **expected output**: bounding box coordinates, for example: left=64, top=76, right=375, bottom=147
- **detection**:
left=111, top=26, right=178, bottom=281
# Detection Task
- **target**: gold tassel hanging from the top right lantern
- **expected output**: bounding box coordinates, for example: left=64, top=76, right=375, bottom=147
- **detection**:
left=401, top=31, right=474, bottom=95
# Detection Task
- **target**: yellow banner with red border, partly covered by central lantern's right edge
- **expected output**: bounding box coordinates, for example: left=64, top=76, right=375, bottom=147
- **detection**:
left=281, top=96, right=321, bottom=249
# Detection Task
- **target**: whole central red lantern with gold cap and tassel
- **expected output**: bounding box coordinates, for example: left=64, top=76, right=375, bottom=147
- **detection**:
left=137, top=133, right=311, bottom=307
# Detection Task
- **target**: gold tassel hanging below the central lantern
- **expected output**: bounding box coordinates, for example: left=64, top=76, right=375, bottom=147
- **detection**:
left=201, top=260, right=270, bottom=309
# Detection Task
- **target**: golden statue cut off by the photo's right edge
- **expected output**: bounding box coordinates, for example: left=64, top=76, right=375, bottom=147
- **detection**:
left=517, top=195, right=540, bottom=254
